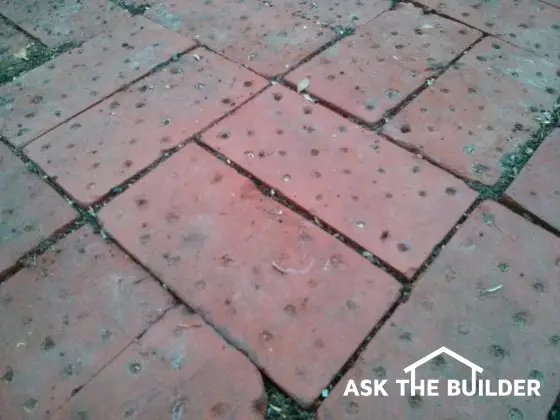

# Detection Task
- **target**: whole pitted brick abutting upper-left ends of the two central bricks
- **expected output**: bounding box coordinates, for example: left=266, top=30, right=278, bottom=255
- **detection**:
left=26, top=48, right=267, bottom=203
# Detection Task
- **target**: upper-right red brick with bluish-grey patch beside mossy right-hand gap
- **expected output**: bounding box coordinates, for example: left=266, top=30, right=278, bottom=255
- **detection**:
left=383, top=38, right=560, bottom=185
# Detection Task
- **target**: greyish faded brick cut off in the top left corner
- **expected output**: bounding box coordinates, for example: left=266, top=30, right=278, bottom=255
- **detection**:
left=2, top=0, right=128, bottom=47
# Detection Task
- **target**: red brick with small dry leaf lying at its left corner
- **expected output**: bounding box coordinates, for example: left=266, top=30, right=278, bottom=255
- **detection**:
left=287, top=4, right=480, bottom=123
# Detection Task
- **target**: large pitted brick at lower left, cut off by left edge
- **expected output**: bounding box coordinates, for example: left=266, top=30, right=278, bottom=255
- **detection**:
left=0, top=228, right=171, bottom=419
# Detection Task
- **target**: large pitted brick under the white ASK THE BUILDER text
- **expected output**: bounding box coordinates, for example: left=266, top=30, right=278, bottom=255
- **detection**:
left=319, top=202, right=560, bottom=420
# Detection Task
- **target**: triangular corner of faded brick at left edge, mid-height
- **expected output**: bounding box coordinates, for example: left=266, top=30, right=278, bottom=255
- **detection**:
left=0, top=144, right=77, bottom=277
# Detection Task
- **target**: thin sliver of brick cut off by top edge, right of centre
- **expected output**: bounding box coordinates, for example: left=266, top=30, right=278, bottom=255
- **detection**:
left=273, top=0, right=390, bottom=27
